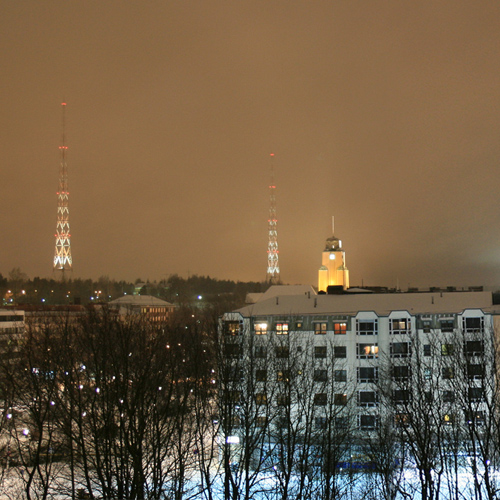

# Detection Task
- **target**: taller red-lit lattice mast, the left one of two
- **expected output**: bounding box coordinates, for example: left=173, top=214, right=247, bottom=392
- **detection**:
left=54, top=102, right=73, bottom=280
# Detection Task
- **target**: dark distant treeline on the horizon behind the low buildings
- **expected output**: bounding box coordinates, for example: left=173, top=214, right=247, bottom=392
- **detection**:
left=0, top=268, right=269, bottom=306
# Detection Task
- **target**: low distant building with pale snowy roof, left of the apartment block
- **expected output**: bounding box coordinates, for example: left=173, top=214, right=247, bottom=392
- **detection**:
left=108, top=295, right=175, bottom=324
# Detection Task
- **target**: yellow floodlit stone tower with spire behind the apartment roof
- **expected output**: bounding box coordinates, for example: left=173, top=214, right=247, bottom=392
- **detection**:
left=318, top=217, right=349, bottom=292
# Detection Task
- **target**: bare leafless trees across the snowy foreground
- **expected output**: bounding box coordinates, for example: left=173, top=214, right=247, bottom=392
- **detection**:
left=0, top=307, right=500, bottom=500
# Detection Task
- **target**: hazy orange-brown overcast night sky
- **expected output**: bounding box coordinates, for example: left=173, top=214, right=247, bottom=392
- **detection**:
left=0, top=0, right=500, bottom=288
